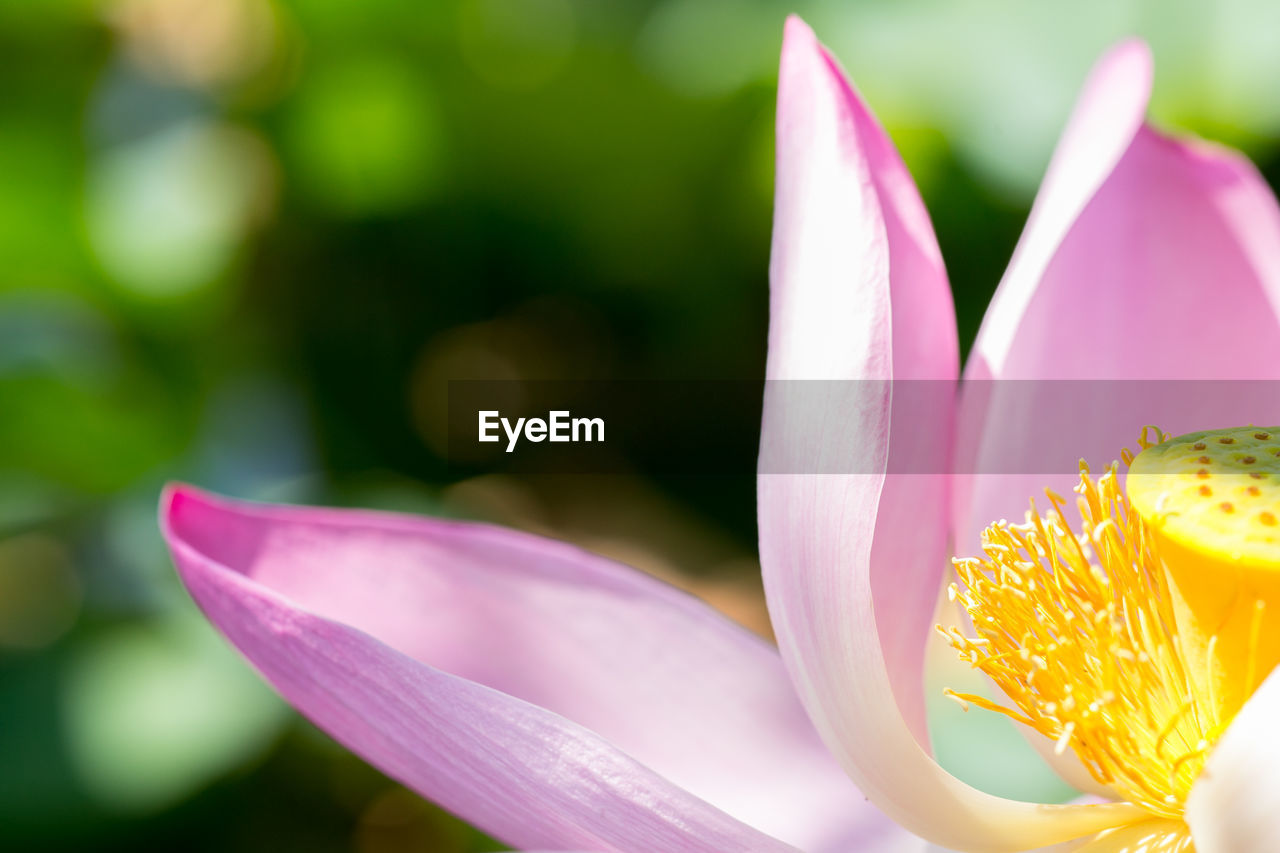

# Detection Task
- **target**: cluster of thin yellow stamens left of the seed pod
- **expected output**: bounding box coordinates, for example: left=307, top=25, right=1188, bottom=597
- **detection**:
left=938, top=452, right=1229, bottom=817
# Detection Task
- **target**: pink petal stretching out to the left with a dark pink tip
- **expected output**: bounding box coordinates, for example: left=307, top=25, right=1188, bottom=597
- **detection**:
left=164, top=488, right=892, bottom=849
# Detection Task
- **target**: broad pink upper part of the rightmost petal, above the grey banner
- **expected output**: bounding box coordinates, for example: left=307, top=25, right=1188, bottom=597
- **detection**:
left=993, top=127, right=1280, bottom=380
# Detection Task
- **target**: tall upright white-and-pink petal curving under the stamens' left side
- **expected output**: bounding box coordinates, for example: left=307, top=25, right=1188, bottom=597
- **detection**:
left=759, top=18, right=1140, bottom=850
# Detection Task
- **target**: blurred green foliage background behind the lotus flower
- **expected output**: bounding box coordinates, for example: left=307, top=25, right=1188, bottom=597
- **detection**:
left=0, top=0, right=1280, bottom=852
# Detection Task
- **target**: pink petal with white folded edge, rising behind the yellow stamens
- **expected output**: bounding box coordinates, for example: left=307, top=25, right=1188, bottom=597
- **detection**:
left=956, top=44, right=1280, bottom=553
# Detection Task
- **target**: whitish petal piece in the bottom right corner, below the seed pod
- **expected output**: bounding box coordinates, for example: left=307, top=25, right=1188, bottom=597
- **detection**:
left=1187, top=670, right=1280, bottom=853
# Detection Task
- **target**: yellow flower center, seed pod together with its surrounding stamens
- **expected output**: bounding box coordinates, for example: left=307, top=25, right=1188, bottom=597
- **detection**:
left=940, top=427, right=1280, bottom=817
